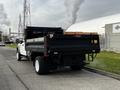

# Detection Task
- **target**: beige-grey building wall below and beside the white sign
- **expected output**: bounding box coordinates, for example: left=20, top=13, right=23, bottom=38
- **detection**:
left=105, top=24, right=120, bottom=52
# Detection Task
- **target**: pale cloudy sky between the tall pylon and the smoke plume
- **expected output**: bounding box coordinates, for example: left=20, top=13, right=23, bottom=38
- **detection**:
left=32, top=0, right=65, bottom=26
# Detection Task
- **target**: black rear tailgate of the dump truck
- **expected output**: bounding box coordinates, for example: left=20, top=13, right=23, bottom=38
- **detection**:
left=48, top=35, right=100, bottom=53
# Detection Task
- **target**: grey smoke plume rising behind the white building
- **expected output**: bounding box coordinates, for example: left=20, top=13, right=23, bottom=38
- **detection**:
left=64, top=0, right=85, bottom=27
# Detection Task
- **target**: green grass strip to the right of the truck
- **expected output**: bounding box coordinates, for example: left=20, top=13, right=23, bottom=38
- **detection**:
left=88, top=51, right=120, bottom=74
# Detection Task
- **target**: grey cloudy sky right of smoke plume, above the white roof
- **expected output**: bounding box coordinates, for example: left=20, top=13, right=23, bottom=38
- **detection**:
left=78, top=0, right=120, bottom=22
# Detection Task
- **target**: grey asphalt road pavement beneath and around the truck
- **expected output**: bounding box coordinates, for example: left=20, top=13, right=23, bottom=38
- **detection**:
left=0, top=47, right=120, bottom=90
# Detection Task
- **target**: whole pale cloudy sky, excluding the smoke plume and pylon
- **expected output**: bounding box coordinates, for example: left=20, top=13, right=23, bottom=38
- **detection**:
left=0, top=0, right=120, bottom=31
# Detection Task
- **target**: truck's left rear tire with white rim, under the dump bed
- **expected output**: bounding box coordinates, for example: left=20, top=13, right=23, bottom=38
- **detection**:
left=35, top=56, right=49, bottom=74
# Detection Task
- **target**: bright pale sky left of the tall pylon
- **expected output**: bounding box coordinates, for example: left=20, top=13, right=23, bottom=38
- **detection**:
left=0, top=0, right=23, bottom=31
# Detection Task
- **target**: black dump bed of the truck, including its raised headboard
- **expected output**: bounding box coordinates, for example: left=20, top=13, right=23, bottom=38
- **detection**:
left=25, top=27, right=100, bottom=53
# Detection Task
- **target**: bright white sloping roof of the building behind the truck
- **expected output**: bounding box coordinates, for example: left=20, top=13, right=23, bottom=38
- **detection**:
left=67, top=14, right=120, bottom=34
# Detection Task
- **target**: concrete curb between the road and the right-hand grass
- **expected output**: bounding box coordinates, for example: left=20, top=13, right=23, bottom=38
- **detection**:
left=84, top=67, right=120, bottom=81
